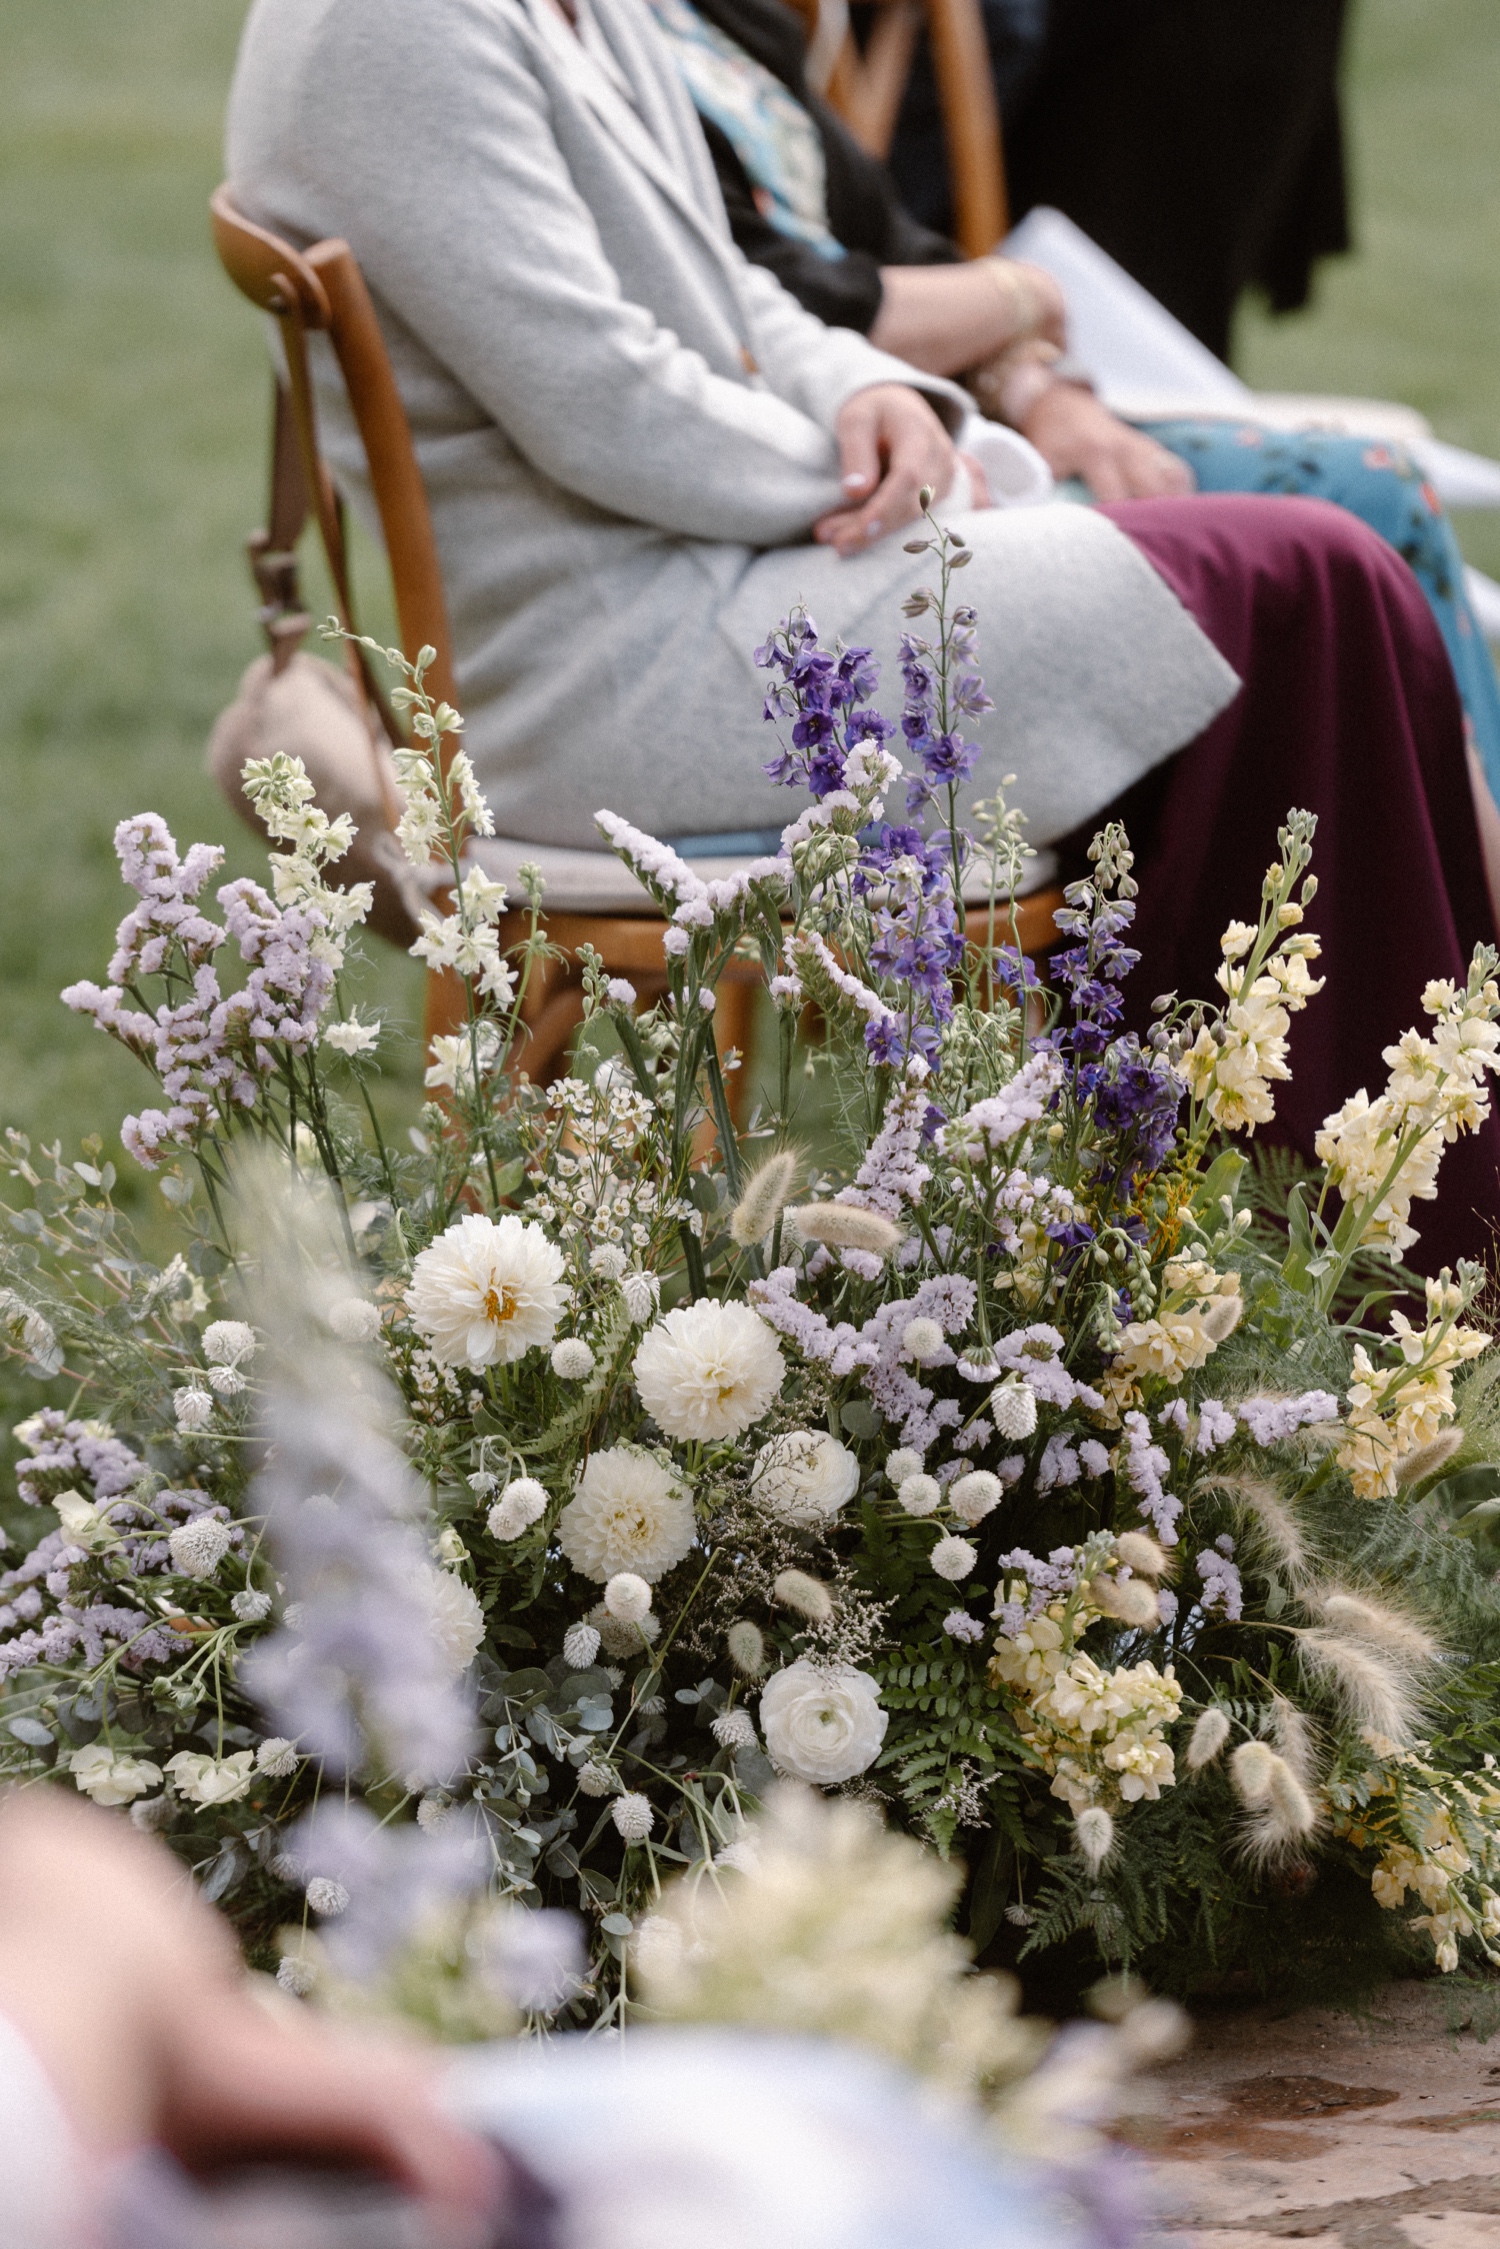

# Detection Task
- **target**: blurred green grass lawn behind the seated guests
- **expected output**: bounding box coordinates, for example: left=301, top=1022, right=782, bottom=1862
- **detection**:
left=0, top=0, right=1500, bottom=1205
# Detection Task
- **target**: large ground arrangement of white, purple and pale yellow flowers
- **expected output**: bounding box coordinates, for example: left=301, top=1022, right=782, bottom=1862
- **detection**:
left=0, top=522, right=1500, bottom=2024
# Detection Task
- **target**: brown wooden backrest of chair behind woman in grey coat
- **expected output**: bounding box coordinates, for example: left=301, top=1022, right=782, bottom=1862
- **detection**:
left=209, top=187, right=459, bottom=704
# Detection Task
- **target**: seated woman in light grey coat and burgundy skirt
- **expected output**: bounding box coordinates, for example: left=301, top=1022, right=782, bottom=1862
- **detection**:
left=229, top=0, right=1493, bottom=1259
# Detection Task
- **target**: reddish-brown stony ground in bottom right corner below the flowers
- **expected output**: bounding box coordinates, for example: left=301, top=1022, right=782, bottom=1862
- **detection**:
left=1131, top=1984, right=1500, bottom=2249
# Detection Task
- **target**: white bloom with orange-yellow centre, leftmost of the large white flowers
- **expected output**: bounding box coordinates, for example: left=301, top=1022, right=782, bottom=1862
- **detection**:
left=407, top=1212, right=562, bottom=1372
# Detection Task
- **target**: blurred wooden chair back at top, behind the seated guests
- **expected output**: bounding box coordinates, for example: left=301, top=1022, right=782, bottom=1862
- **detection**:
left=796, top=0, right=1010, bottom=259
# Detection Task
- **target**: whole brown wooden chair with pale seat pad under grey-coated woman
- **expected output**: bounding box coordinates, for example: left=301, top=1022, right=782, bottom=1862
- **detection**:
left=209, top=187, right=1061, bottom=1104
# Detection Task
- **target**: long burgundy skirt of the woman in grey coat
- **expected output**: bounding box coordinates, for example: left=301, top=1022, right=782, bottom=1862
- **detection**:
left=1093, top=495, right=1500, bottom=1271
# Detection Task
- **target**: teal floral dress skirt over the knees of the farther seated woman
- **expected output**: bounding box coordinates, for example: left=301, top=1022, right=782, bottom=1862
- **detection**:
left=1140, top=421, right=1500, bottom=798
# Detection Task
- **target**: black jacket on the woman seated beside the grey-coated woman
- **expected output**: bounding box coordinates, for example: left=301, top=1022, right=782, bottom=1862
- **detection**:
left=693, top=0, right=960, bottom=335
